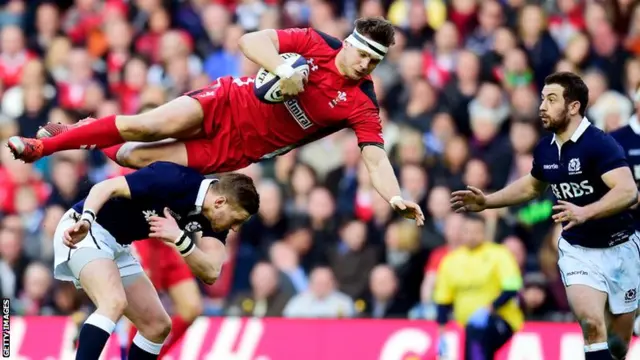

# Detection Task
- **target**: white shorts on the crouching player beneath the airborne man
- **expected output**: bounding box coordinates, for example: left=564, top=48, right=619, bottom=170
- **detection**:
left=53, top=209, right=144, bottom=288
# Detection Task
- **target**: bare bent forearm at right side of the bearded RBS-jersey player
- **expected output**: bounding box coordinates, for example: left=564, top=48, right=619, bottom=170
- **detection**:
left=584, top=166, right=638, bottom=219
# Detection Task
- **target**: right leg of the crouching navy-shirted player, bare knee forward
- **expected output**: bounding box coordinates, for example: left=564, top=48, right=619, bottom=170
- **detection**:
left=123, top=274, right=171, bottom=359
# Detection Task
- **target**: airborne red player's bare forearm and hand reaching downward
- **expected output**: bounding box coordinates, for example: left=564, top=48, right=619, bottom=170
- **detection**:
left=362, top=145, right=424, bottom=226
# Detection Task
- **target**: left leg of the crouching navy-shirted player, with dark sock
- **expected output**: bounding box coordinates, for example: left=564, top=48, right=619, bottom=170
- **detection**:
left=75, top=258, right=127, bottom=359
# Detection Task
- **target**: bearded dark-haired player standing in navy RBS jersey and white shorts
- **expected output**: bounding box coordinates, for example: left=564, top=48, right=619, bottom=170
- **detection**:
left=451, top=72, right=640, bottom=360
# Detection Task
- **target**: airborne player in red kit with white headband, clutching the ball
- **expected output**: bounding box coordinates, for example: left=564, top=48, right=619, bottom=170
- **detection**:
left=8, top=18, right=424, bottom=225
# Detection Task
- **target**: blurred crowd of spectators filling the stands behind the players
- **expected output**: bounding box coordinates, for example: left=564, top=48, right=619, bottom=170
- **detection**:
left=0, top=0, right=640, bottom=321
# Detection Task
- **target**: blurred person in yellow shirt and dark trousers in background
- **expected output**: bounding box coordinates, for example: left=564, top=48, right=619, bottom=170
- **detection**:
left=434, top=214, right=524, bottom=360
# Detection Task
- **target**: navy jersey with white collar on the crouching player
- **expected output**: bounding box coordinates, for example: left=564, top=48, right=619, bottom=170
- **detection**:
left=73, top=162, right=229, bottom=244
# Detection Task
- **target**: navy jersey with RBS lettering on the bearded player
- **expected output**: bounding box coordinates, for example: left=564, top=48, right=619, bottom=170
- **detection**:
left=531, top=119, right=634, bottom=248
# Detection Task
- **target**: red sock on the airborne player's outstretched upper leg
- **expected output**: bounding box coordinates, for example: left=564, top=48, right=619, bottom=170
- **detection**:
left=42, top=115, right=125, bottom=156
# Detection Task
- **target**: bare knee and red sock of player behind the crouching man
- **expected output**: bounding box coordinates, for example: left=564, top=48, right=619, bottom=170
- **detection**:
left=160, top=279, right=203, bottom=357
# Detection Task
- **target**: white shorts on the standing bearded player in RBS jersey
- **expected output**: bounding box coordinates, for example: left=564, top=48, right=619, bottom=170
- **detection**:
left=558, top=232, right=640, bottom=315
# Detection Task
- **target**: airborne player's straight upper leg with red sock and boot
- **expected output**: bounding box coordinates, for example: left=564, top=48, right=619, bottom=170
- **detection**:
left=7, top=96, right=204, bottom=162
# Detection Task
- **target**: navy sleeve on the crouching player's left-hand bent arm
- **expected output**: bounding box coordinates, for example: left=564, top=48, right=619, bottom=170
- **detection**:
left=125, top=162, right=185, bottom=200
